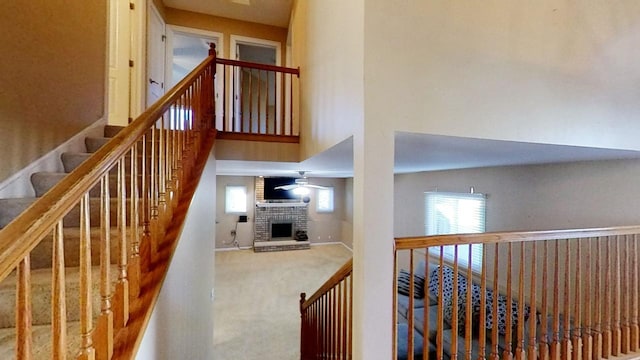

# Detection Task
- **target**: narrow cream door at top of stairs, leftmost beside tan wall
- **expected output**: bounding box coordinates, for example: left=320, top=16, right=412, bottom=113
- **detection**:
left=109, top=0, right=131, bottom=126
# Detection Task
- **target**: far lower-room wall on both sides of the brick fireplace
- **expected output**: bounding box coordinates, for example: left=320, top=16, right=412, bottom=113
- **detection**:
left=216, top=176, right=352, bottom=249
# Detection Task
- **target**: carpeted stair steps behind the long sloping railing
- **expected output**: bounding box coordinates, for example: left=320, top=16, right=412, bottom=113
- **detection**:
left=0, top=125, right=123, bottom=359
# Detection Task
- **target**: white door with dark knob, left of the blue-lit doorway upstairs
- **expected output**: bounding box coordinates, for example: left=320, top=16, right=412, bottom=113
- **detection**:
left=147, top=6, right=166, bottom=107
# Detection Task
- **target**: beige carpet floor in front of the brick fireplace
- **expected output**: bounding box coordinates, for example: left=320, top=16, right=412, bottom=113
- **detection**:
left=213, top=245, right=351, bottom=360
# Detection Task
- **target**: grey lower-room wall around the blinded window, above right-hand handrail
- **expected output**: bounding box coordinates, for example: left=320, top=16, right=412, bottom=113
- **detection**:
left=394, top=160, right=640, bottom=237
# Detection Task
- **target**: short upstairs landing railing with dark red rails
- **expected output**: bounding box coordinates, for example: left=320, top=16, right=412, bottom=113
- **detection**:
left=215, top=47, right=300, bottom=142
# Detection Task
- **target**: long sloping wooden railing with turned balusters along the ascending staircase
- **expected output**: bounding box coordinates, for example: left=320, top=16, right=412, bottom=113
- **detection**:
left=0, top=44, right=215, bottom=359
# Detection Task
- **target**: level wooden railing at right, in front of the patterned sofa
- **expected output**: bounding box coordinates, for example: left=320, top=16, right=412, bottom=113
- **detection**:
left=393, top=227, right=640, bottom=359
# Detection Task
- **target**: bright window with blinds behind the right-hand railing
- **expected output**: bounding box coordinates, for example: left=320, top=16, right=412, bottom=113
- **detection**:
left=425, top=192, right=486, bottom=271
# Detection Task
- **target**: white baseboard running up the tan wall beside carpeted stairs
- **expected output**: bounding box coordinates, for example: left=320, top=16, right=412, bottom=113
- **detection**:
left=0, top=119, right=107, bottom=199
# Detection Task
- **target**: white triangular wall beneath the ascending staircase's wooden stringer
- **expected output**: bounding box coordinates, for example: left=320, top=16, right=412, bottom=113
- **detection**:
left=136, top=150, right=216, bottom=360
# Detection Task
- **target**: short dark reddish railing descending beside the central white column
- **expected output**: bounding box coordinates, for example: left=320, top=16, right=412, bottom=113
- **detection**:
left=300, top=260, right=353, bottom=360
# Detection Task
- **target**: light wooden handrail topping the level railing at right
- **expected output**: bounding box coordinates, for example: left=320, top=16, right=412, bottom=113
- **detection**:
left=395, top=226, right=640, bottom=250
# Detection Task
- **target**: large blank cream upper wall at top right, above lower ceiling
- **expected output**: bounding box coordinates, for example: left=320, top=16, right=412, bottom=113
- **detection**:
left=364, top=0, right=640, bottom=149
